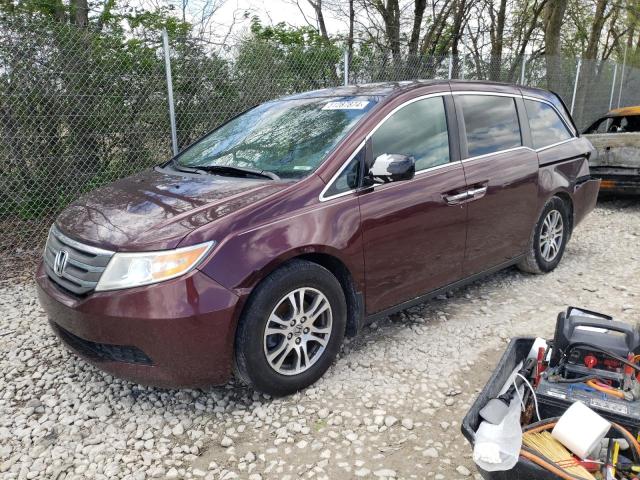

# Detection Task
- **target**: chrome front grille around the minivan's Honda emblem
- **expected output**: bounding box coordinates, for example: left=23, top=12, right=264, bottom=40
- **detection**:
left=44, top=225, right=114, bottom=295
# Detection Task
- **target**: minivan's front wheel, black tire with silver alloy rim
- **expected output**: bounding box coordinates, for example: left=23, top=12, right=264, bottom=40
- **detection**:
left=235, top=260, right=347, bottom=396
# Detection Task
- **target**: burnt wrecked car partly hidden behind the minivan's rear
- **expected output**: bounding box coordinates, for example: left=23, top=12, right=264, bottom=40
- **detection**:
left=584, top=107, right=640, bottom=195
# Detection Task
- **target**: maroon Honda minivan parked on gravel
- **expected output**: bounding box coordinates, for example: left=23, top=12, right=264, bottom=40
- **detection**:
left=37, top=81, right=599, bottom=395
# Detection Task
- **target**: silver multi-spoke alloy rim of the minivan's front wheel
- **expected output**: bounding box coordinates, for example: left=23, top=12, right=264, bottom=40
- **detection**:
left=264, top=287, right=333, bottom=375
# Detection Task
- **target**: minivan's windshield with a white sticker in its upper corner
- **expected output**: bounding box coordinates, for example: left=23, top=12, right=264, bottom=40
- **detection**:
left=176, top=96, right=379, bottom=178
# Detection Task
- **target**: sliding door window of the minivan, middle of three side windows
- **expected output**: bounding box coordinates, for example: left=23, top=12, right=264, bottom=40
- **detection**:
left=457, top=95, right=522, bottom=157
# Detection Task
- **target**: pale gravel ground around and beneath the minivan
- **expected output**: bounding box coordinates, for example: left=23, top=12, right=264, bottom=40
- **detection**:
left=0, top=200, right=640, bottom=480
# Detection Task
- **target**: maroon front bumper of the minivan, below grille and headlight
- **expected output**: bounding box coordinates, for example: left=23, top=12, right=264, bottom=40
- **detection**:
left=36, top=265, right=239, bottom=388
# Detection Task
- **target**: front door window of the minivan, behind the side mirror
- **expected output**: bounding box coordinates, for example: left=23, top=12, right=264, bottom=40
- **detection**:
left=371, top=97, right=449, bottom=171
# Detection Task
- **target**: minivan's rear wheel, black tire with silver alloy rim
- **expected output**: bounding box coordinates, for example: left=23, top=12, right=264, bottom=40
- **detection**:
left=518, top=197, right=571, bottom=274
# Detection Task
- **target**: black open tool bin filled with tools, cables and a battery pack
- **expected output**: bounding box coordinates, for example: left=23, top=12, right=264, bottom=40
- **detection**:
left=462, top=307, right=640, bottom=480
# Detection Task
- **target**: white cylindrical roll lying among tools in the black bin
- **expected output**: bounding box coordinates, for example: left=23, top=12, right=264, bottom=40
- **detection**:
left=551, top=402, right=611, bottom=460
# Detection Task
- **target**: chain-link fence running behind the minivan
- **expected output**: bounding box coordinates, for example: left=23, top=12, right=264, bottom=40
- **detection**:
left=0, top=17, right=640, bottom=250
